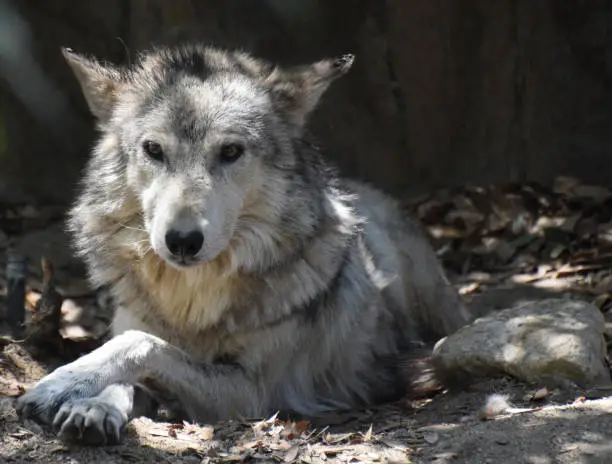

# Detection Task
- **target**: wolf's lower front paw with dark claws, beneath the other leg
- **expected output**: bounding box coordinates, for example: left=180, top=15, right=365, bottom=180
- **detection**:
left=53, top=398, right=128, bottom=445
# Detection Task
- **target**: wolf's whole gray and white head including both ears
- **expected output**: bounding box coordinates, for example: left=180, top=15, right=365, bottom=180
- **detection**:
left=63, top=46, right=353, bottom=268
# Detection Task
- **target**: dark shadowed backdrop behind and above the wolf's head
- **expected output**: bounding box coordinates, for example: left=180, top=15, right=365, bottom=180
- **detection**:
left=0, top=0, right=612, bottom=202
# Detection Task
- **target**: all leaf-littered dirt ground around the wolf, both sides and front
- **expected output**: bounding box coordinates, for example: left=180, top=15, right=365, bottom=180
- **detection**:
left=0, top=179, right=612, bottom=464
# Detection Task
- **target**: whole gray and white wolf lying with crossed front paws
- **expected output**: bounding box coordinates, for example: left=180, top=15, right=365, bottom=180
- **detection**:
left=17, top=43, right=470, bottom=444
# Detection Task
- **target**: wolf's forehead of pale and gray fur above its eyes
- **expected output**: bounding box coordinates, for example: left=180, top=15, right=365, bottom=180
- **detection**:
left=146, top=74, right=270, bottom=137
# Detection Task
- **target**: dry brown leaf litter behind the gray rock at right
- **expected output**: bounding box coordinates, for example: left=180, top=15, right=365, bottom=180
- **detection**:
left=404, top=177, right=612, bottom=330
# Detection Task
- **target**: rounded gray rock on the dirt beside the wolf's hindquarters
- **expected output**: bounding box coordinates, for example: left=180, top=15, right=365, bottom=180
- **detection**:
left=434, top=298, right=611, bottom=386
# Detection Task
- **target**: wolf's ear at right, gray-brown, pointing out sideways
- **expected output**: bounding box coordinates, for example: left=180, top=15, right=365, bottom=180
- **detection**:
left=265, top=55, right=355, bottom=128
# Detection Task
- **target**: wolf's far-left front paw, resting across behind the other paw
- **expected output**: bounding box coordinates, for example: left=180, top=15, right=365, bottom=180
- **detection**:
left=16, top=368, right=91, bottom=425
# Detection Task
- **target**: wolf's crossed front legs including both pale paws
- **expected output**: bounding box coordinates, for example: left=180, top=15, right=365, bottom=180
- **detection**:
left=17, top=330, right=261, bottom=442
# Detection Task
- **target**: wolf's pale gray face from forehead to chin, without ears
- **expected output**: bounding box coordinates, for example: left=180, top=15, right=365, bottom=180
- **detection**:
left=117, top=74, right=274, bottom=266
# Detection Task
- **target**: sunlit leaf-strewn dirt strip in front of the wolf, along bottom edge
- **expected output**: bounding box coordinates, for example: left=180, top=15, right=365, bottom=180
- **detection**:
left=0, top=346, right=612, bottom=464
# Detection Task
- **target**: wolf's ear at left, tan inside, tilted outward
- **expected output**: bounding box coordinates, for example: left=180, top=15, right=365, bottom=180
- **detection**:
left=62, top=48, right=122, bottom=123
